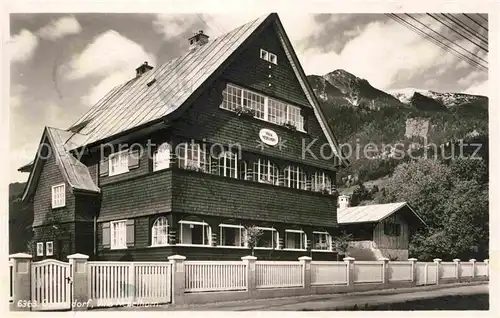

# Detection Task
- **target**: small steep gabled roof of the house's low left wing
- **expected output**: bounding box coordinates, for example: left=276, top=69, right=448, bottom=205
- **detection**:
left=22, top=127, right=100, bottom=200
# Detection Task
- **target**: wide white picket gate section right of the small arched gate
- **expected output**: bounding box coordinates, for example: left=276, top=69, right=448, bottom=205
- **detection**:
left=88, top=262, right=172, bottom=307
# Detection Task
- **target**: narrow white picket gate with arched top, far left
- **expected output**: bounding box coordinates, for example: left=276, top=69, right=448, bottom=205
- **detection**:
left=31, top=259, right=72, bottom=310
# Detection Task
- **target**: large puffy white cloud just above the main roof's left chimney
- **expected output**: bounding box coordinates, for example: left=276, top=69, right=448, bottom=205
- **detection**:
left=64, top=30, right=156, bottom=105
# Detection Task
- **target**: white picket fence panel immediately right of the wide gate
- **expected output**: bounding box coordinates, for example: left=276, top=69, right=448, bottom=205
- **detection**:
left=184, top=261, right=247, bottom=292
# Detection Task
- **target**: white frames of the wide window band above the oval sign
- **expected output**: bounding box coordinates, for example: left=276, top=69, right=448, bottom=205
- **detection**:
left=219, top=83, right=305, bottom=132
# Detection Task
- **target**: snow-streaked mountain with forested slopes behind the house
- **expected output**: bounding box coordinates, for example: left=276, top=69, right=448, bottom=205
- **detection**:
left=308, top=70, right=488, bottom=185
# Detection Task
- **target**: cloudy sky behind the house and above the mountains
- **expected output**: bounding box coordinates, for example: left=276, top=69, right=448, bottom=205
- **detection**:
left=7, top=12, right=488, bottom=182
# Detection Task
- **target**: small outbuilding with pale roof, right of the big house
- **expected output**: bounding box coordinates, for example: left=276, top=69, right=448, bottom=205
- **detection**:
left=337, top=195, right=425, bottom=261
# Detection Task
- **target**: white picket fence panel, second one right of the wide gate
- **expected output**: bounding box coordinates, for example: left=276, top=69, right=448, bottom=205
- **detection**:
left=255, top=261, right=304, bottom=288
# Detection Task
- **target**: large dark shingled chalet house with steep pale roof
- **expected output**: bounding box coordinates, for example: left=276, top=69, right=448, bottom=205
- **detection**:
left=20, top=13, right=348, bottom=261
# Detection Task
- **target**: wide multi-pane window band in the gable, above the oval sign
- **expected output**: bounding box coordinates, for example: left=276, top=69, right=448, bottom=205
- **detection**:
left=220, top=84, right=304, bottom=131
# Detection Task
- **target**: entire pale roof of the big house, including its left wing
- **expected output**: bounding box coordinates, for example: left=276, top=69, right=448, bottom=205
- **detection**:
left=22, top=13, right=349, bottom=201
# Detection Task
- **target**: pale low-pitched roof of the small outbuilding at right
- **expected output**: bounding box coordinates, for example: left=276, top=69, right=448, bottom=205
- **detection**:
left=337, top=202, right=425, bottom=225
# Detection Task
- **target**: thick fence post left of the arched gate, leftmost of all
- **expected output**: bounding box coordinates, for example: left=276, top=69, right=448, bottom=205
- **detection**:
left=9, top=253, right=32, bottom=311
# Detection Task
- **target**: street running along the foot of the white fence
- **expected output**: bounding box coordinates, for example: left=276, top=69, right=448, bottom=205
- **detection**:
left=97, top=283, right=489, bottom=311
